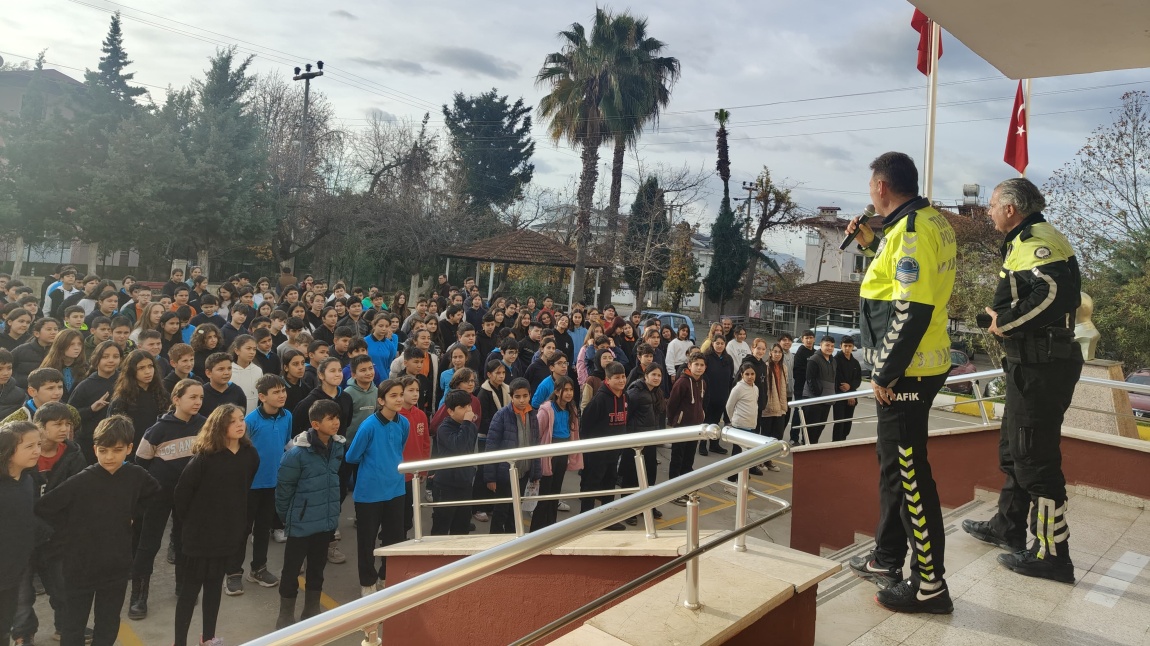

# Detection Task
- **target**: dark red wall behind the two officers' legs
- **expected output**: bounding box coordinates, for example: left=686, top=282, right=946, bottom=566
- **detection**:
left=790, top=429, right=1150, bottom=554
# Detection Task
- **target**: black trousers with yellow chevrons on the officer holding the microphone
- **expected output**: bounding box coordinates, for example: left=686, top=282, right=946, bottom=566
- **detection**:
left=874, top=375, right=946, bottom=590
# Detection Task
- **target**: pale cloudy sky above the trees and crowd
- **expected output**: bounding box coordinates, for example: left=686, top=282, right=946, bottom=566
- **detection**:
left=0, top=0, right=1150, bottom=252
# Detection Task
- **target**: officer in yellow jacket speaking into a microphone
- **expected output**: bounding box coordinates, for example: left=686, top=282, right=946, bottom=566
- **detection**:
left=848, top=153, right=956, bottom=614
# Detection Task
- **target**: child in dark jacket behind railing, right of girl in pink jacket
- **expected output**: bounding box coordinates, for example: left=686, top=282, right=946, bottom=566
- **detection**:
left=578, top=361, right=627, bottom=531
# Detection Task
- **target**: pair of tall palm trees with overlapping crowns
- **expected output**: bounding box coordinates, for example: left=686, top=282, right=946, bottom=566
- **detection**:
left=535, top=8, right=679, bottom=295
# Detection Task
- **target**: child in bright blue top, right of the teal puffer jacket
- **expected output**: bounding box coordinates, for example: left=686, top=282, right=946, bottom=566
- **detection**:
left=344, top=379, right=408, bottom=597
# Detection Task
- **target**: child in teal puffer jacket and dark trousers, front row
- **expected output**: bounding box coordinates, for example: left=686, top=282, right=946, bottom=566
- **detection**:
left=276, top=399, right=346, bottom=630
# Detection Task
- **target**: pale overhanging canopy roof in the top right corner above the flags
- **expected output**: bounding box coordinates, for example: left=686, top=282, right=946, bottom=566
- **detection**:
left=910, top=0, right=1150, bottom=78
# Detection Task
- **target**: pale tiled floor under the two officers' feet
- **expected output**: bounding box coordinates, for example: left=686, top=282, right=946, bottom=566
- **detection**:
left=815, top=495, right=1150, bottom=646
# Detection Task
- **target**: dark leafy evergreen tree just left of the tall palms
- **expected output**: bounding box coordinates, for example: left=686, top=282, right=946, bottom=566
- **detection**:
left=443, top=89, right=535, bottom=212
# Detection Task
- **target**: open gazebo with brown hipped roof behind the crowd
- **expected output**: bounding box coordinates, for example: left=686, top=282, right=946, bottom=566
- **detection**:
left=439, top=229, right=606, bottom=309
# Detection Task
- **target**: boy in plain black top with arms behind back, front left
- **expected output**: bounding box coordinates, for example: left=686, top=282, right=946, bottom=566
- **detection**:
left=36, top=415, right=160, bottom=646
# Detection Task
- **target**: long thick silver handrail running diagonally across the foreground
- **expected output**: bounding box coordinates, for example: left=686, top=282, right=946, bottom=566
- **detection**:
left=238, top=426, right=790, bottom=646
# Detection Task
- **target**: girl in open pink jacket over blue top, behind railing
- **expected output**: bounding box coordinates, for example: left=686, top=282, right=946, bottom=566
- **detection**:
left=531, top=377, right=583, bottom=531
